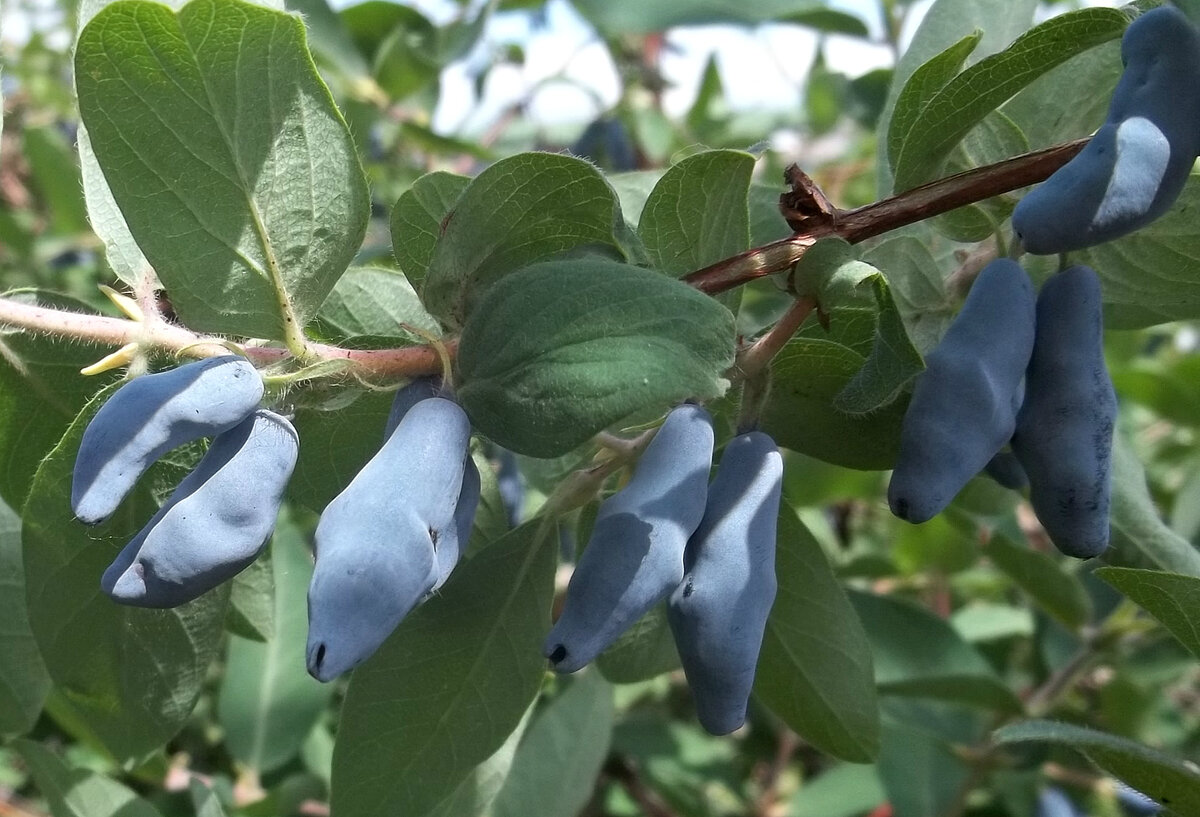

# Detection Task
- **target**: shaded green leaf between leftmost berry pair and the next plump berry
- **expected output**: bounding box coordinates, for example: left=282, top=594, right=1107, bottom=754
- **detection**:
left=288, top=391, right=395, bottom=513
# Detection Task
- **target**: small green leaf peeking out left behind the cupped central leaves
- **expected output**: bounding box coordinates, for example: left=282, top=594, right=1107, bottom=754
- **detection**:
left=388, top=171, right=470, bottom=284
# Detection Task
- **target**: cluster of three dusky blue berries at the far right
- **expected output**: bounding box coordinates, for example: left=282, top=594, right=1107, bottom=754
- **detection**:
left=888, top=6, right=1200, bottom=559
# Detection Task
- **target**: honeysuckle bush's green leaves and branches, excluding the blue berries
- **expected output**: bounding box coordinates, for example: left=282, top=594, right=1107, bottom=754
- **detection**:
left=0, top=0, right=1200, bottom=817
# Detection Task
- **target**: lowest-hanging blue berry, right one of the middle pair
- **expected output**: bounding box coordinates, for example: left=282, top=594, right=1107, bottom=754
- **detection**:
left=667, top=432, right=784, bottom=734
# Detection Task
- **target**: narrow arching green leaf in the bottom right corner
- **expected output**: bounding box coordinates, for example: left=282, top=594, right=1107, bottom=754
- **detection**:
left=992, top=721, right=1200, bottom=815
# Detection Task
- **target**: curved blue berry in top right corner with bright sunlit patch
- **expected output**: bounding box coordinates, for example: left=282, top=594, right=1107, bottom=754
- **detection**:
left=1013, top=6, right=1200, bottom=253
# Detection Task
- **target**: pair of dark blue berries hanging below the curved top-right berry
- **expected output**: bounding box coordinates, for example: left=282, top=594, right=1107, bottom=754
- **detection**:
left=888, top=259, right=1117, bottom=559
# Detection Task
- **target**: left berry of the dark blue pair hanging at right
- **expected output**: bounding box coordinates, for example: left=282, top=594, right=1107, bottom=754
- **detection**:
left=888, top=258, right=1034, bottom=522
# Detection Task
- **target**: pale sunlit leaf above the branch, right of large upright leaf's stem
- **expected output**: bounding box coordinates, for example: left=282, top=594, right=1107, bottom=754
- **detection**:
left=317, top=266, right=442, bottom=347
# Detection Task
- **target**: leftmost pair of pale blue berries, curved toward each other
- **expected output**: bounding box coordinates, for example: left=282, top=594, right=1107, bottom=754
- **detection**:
left=71, top=355, right=299, bottom=607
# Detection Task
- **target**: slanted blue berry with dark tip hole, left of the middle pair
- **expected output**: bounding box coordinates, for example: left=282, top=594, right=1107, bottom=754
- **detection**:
left=542, top=406, right=713, bottom=672
